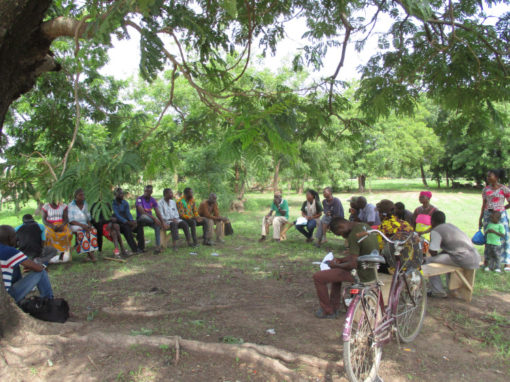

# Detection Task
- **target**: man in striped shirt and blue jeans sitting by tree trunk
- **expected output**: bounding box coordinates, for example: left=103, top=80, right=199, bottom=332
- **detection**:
left=0, top=225, right=53, bottom=303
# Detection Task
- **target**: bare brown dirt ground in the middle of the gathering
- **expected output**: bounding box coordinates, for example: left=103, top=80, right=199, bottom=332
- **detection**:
left=0, top=234, right=510, bottom=382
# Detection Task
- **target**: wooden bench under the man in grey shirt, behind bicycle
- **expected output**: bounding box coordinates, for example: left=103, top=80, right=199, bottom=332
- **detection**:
left=421, top=263, right=476, bottom=302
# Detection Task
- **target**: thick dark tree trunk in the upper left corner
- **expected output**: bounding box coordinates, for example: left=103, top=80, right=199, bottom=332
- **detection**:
left=0, top=0, right=60, bottom=128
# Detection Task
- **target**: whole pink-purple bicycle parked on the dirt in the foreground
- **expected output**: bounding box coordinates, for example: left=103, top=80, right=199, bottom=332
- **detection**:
left=342, top=230, right=427, bottom=382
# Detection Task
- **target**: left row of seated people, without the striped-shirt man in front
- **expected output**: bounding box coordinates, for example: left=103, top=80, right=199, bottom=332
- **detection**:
left=16, top=185, right=229, bottom=262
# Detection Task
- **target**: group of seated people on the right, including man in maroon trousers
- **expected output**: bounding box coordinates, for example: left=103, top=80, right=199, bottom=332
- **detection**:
left=259, top=188, right=480, bottom=318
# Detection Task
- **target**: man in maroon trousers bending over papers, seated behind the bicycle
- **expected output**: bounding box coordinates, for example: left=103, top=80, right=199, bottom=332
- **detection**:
left=313, top=217, right=379, bottom=318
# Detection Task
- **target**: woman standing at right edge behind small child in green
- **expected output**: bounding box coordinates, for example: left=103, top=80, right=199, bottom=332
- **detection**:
left=478, top=170, right=510, bottom=272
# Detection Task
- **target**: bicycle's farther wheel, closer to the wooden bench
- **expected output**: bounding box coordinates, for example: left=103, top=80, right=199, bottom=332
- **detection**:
left=396, top=271, right=427, bottom=343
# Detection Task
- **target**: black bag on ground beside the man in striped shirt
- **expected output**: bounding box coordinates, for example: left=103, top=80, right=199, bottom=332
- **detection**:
left=19, top=296, right=69, bottom=323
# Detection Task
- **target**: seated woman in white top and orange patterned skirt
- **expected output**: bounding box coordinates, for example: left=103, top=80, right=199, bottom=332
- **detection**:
left=42, top=201, right=73, bottom=262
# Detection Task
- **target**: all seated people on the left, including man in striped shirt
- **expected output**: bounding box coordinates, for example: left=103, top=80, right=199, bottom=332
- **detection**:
left=0, top=185, right=231, bottom=303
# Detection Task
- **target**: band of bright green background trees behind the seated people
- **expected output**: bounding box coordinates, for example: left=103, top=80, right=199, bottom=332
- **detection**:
left=0, top=41, right=510, bottom=215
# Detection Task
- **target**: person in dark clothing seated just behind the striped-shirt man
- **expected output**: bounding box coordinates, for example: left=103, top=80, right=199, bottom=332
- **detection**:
left=14, top=214, right=58, bottom=263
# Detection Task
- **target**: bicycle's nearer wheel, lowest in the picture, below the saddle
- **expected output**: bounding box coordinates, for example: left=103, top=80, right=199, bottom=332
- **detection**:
left=343, top=293, right=381, bottom=382
